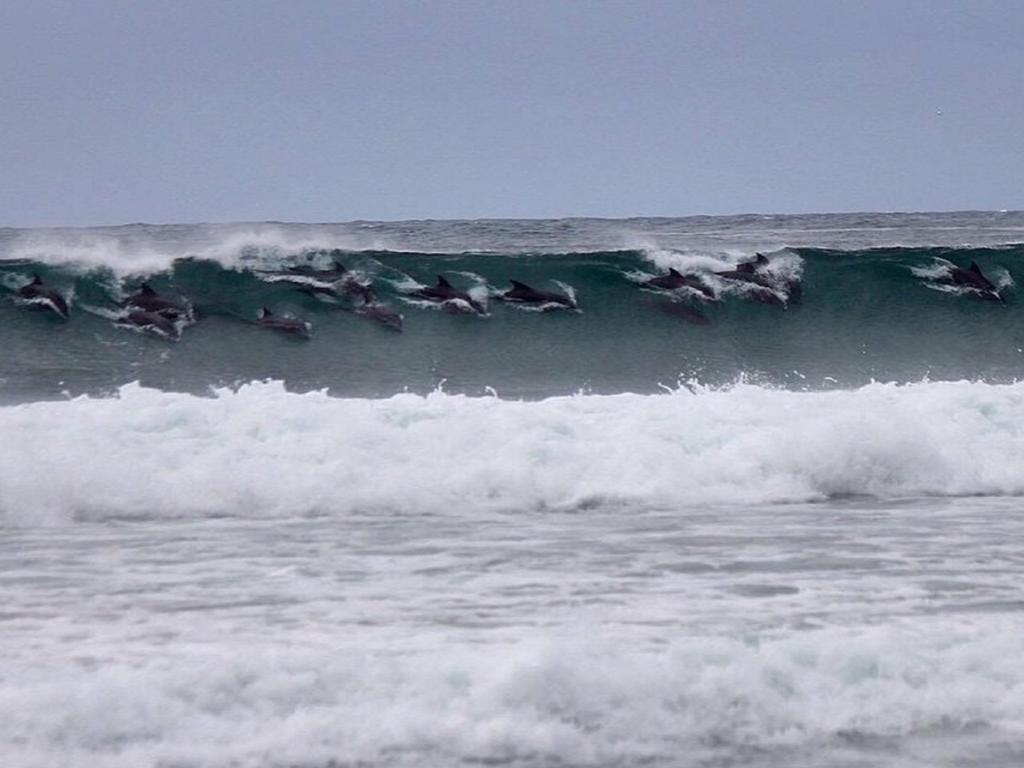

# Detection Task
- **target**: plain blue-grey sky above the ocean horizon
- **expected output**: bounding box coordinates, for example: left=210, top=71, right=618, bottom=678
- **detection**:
left=0, top=0, right=1024, bottom=225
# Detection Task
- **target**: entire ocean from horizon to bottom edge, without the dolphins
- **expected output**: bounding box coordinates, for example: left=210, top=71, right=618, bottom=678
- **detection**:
left=0, top=212, right=1024, bottom=768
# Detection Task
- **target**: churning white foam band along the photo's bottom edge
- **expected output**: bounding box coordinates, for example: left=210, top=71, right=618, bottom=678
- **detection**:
left=0, top=620, right=1024, bottom=768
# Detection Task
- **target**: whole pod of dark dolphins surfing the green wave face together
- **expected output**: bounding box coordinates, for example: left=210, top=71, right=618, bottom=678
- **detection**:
left=8, top=253, right=1004, bottom=339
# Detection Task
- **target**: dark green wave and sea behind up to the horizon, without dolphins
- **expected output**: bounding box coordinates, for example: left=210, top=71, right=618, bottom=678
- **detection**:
left=0, top=214, right=1024, bottom=401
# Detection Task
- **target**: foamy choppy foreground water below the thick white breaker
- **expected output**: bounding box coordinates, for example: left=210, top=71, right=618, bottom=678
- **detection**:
left=0, top=500, right=1024, bottom=766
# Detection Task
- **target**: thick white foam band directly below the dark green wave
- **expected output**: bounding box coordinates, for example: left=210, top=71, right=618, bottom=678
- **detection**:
left=0, top=382, right=1024, bottom=525
